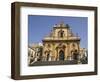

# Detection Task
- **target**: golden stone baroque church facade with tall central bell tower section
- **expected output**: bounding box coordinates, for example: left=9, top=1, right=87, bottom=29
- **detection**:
left=42, top=23, right=80, bottom=61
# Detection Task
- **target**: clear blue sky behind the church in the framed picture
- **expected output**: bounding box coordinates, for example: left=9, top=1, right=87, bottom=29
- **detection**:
left=28, top=15, right=88, bottom=48
